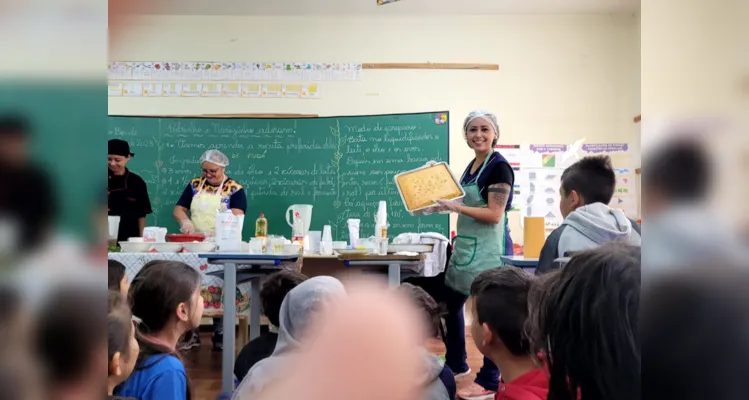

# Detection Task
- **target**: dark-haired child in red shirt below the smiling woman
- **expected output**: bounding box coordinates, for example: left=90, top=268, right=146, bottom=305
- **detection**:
left=471, top=267, right=549, bottom=400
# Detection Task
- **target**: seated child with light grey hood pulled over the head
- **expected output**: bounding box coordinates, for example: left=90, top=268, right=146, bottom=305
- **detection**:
left=233, top=276, right=346, bottom=400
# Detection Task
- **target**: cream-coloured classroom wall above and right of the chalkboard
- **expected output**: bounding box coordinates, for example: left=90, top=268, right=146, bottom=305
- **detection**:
left=109, top=16, right=640, bottom=239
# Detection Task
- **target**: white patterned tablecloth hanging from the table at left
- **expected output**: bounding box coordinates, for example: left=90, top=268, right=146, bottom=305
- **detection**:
left=109, top=253, right=250, bottom=316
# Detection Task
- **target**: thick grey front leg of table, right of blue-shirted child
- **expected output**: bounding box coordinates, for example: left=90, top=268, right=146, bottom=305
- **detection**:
left=221, top=264, right=237, bottom=393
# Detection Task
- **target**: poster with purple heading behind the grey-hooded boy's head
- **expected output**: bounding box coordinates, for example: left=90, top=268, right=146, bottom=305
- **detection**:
left=580, top=143, right=639, bottom=219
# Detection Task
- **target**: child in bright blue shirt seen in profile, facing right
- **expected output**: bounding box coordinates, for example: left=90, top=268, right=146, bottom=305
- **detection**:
left=115, top=260, right=203, bottom=400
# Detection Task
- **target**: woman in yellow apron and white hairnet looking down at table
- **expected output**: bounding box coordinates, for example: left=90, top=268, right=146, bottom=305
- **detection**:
left=173, top=149, right=247, bottom=350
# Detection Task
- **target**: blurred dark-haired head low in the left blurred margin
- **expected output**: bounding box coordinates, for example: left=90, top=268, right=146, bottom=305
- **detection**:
left=36, top=286, right=107, bottom=388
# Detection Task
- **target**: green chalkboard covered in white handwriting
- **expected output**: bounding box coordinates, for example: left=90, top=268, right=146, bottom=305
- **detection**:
left=108, top=112, right=449, bottom=240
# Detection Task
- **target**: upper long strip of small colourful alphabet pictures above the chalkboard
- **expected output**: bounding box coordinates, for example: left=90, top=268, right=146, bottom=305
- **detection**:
left=107, top=61, right=363, bottom=82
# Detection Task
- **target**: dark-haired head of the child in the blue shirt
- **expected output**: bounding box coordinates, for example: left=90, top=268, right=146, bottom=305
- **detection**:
left=129, top=260, right=203, bottom=335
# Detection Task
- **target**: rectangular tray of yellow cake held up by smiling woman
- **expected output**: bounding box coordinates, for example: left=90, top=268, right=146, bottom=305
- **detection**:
left=395, top=163, right=465, bottom=211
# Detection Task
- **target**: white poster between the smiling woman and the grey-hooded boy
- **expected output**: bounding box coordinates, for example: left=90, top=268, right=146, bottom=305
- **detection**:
left=517, top=144, right=576, bottom=229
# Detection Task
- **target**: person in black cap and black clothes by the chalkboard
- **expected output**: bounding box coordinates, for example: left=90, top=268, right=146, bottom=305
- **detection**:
left=107, top=139, right=151, bottom=241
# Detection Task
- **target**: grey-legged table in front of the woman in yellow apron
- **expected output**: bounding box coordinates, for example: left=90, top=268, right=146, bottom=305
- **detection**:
left=198, top=253, right=301, bottom=393
